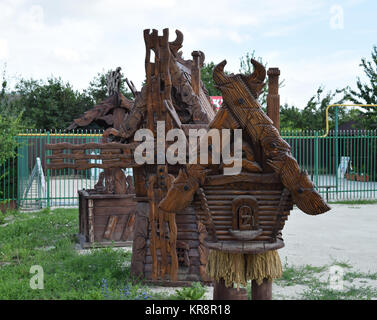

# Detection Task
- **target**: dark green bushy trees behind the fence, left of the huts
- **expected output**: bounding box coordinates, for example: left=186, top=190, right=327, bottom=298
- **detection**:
left=0, top=72, right=132, bottom=130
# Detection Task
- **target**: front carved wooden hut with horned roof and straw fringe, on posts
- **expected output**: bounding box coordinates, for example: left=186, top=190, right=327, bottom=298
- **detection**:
left=159, top=60, right=330, bottom=299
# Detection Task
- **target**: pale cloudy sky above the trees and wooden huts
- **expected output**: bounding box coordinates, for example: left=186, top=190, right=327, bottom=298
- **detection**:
left=0, top=0, right=377, bottom=107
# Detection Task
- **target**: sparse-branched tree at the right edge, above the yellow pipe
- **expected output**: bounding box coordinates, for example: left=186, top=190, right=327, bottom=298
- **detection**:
left=346, top=46, right=377, bottom=129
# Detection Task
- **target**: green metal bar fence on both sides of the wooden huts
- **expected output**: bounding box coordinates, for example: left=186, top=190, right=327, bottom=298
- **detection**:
left=0, top=130, right=377, bottom=210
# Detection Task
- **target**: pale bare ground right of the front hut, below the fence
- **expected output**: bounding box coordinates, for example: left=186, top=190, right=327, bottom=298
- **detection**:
left=279, top=204, right=377, bottom=273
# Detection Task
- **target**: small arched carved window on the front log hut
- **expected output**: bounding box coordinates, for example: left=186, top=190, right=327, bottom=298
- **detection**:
left=232, top=196, right=259, bottom=230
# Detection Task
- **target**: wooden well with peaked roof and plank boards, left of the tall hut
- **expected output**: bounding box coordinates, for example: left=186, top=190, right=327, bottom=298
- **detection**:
left=47, top=68, right=136, bottom=248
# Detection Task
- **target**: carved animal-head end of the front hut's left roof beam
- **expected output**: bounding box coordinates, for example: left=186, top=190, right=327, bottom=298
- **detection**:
left=158, top=169, right=199, bottom=212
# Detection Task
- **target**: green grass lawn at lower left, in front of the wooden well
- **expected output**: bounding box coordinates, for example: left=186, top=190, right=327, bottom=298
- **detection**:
left=0, top=209, right=150, bottom=299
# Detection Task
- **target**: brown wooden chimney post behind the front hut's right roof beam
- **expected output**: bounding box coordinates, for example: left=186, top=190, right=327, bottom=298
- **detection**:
left=267, top=68, right=280, bottom=131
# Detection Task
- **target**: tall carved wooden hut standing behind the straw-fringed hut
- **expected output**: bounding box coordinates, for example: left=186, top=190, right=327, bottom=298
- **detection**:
left=128, top=29, right=215, bottom=285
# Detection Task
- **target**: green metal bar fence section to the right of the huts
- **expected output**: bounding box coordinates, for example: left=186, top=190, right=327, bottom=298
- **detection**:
left=282, top=130, right=377, bottom=201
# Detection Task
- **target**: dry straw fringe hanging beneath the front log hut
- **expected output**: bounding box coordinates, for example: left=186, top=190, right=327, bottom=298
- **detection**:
left=206, top=250, right=283, bottom=288
